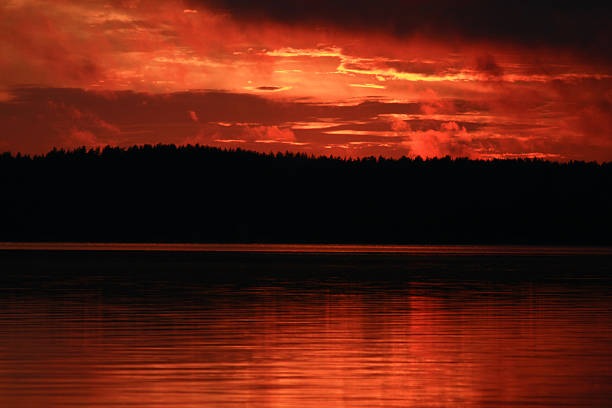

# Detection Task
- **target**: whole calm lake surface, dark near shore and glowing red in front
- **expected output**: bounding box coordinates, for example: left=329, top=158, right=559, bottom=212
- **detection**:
left=0, top=244, right=612, bottom=408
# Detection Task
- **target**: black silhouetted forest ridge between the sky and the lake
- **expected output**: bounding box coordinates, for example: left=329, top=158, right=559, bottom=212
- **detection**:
left=0, top=145, right=612, bottom=245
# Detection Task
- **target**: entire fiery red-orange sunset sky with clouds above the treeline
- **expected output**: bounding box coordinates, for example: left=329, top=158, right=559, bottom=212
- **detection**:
left=0, top=0, right=612, bottom=161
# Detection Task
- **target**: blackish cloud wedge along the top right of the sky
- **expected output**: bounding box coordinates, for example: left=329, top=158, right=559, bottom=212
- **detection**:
left=190, top=0, right=612, bottom=59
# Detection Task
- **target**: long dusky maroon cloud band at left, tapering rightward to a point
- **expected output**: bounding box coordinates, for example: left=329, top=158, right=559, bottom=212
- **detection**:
left=0, top=87, right=421, bottom=125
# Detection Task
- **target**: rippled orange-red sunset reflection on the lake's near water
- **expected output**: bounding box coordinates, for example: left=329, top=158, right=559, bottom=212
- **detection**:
left=0, top=282, right=610, bottom=407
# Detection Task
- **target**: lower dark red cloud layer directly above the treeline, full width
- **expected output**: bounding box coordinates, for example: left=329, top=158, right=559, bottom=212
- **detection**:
left=0, top=86, right=612, bottom=160
